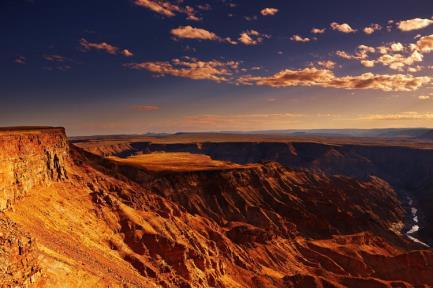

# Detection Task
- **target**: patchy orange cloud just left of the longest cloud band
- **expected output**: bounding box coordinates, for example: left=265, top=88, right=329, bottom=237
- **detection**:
left=124, top=57, right=239, bottom=82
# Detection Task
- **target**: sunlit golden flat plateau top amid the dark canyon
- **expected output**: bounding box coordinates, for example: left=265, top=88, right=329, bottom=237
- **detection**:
left=108, top=152, right=254, bottom=172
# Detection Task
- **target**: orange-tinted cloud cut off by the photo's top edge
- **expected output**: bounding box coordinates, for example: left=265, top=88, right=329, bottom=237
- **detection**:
left=134, top=0, right=200, bottom=21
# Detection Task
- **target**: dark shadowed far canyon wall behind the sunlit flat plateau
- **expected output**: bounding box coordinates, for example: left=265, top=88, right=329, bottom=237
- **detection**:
left=74, top=139, right=433, bottom=243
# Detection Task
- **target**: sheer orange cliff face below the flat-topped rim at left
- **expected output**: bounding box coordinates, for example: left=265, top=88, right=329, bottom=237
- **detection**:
left=0, top=128, right=69, bottom=211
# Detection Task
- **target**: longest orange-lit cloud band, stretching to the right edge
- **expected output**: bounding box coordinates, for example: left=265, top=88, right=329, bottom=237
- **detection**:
left=238, top=67, right=431, bottom=91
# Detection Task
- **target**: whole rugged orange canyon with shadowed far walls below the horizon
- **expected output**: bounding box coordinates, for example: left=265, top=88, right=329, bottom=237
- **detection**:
left=0, top=127, right=433, bottom=288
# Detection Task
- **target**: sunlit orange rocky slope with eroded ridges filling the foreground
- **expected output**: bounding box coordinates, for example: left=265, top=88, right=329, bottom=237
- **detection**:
left=0, top=129, right=433, bottom=288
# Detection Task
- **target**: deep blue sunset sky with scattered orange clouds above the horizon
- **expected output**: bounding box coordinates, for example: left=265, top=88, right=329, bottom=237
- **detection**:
left=0, top=0, right=433, bottom=136
